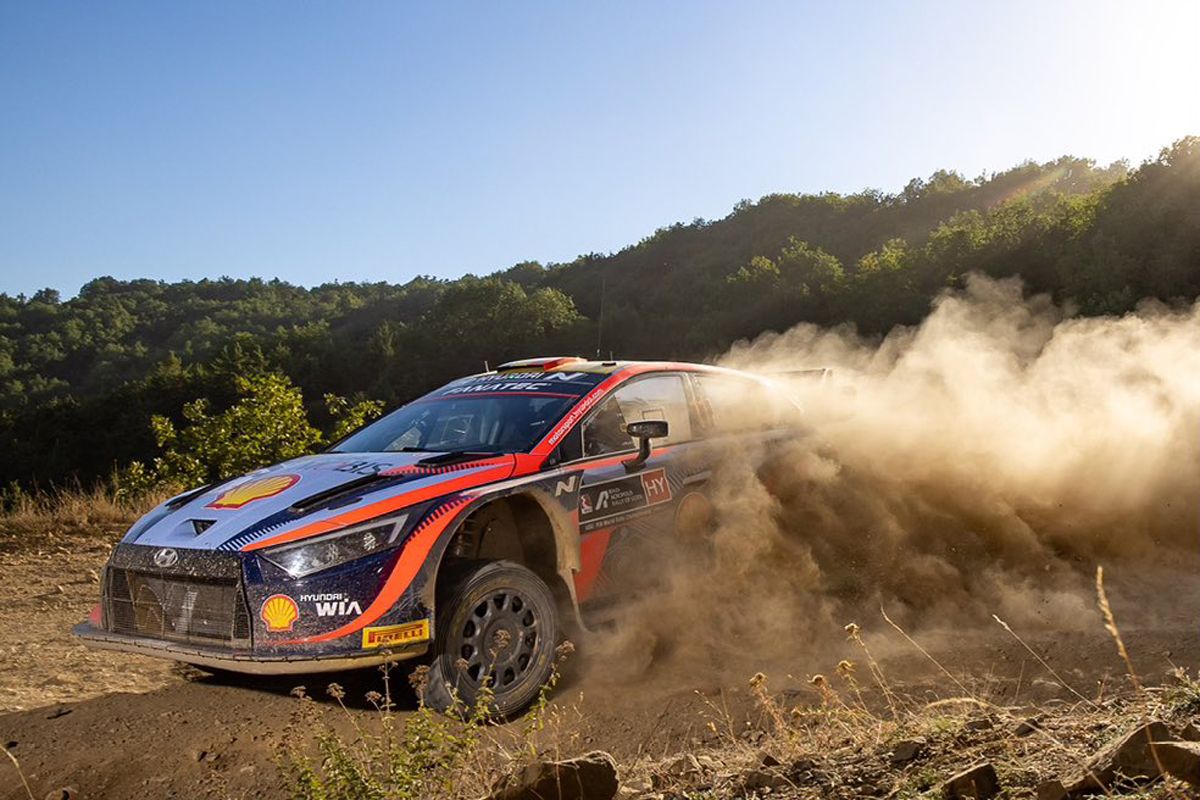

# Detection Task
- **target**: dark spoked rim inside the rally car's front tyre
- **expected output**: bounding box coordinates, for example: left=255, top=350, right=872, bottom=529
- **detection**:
left=456, top=589, right=541, bottom=693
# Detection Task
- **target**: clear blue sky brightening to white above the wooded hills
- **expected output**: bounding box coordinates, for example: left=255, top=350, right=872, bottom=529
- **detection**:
left=0, top=0, right=1200, bottom=295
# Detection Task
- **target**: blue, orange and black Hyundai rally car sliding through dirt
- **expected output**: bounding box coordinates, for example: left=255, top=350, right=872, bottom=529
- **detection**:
left=76, top=359, right=797, bottom=714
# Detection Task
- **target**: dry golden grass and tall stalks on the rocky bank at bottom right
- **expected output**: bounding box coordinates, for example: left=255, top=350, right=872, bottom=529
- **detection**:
left=626, top=576, right=1200, bottom=800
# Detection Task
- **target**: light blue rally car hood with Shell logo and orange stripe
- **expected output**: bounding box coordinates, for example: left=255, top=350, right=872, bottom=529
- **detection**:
left=124, top=453, right=515, bottom=551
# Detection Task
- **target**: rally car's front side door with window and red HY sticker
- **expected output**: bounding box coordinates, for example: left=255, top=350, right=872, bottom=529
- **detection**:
left=564, top=373, right=698, bottom=610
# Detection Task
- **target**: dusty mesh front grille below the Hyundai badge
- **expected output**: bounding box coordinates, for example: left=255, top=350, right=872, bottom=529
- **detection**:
left=104, top=556, right=251, bottom=649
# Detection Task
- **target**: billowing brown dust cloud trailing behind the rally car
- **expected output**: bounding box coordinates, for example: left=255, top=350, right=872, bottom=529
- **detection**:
left=588, top=276, right=1200, bottom=670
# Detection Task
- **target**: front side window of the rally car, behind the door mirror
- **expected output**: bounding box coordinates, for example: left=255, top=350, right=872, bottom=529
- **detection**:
left=583, top=375, right=692, bottom=456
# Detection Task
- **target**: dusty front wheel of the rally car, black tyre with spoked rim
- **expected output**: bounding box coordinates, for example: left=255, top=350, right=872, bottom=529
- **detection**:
left=422, top=561, right=559, bottom=717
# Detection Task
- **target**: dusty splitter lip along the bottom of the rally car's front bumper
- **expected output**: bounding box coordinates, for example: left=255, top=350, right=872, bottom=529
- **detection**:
left=72, top=622, right=430, bottom=675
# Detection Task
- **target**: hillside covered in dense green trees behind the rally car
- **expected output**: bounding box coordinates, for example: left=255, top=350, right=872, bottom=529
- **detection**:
left=0, top=138, right=1200, bottom=487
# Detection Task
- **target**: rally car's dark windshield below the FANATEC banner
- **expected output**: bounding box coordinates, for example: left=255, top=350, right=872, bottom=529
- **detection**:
left=334, top=373, right=599, bottom=453
